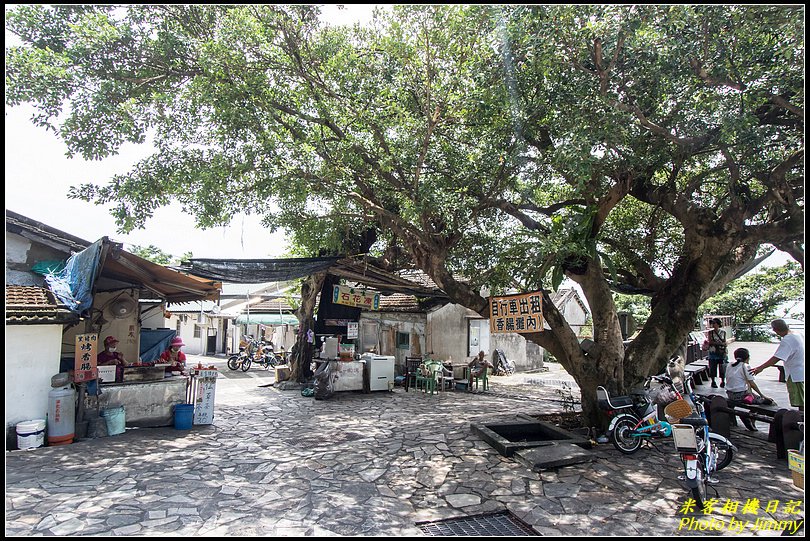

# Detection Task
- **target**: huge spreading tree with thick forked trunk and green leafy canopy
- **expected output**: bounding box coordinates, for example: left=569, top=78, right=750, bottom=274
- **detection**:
left=6, top=5, right=804, bottom=424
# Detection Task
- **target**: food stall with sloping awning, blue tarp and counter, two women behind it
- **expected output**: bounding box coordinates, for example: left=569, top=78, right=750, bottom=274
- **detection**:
left=46, top=237, right=221, bottom=433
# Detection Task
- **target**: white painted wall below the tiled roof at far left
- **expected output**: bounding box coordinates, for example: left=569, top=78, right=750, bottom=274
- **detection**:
left=5, top=325, right=62, bottom=430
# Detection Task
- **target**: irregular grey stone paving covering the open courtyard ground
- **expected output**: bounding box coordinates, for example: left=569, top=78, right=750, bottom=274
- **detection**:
left=6, top=344, right=804, bottom=536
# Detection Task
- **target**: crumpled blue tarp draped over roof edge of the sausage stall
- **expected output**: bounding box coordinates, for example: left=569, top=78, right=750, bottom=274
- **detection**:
left=45, top=239, right=103, bottom=314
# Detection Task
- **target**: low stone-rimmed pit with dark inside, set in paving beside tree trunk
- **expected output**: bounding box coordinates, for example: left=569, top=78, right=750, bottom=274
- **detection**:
left=470, top=421, right=591, bottom=457
